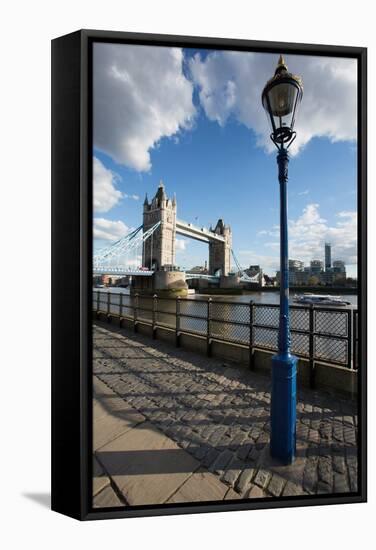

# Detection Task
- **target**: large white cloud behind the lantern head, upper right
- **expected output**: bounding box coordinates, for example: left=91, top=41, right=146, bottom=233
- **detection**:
left=190, top=52, right=357, bottom=153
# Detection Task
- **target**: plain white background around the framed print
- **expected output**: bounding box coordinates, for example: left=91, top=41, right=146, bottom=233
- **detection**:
left=0, top=0, right=376, bottom=550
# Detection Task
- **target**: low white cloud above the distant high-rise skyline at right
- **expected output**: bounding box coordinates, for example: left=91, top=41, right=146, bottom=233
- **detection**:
left=254, top=203, right=357, bottom=272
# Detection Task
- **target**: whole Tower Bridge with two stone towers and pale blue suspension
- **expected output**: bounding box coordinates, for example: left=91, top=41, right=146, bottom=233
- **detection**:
left=93, top=182, right=258, bottom=291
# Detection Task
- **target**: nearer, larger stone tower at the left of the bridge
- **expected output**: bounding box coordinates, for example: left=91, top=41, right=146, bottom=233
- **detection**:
left=142, top=181, right=176, bottom=271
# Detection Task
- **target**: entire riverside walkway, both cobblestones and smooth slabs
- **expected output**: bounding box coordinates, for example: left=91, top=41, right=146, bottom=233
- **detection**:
left=93, top=322, right=357, bottom=507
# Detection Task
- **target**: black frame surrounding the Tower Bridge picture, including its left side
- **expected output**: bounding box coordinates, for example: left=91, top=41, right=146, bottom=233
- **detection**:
left=52, top=30, right=367, bottom=520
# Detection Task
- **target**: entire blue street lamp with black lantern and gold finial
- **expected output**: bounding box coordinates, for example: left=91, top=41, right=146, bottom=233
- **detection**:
left=262, top=56, right=303, bottom=464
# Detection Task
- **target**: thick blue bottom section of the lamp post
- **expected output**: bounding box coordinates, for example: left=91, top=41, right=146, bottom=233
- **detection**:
left=270, top=353, right=298, bottom=464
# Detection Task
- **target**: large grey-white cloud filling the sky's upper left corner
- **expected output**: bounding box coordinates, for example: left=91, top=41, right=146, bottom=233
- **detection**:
left=94, top=43, right=195, bottom=171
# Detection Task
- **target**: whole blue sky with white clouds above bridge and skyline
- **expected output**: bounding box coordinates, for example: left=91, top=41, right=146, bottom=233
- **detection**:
left=94, top=44, right=357, bottom=275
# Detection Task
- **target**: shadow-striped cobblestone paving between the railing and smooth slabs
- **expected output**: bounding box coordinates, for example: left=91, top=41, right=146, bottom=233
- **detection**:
left=93, top=323, right=357, bottom=498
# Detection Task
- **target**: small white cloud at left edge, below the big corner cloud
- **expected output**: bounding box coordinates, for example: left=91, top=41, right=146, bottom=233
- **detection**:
left=93, top=157, right=123, bottom=212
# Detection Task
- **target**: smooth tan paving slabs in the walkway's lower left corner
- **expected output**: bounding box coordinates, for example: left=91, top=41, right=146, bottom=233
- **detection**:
left=93, top=376, right=232, bottom=507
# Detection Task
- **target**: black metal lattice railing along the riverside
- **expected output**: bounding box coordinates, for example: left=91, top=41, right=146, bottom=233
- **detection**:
left=93, top=290, right=358, bottom=385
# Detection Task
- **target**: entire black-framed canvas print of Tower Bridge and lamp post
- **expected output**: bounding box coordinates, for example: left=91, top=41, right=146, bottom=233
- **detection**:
left=52, top=30, right=366, bottom=519
